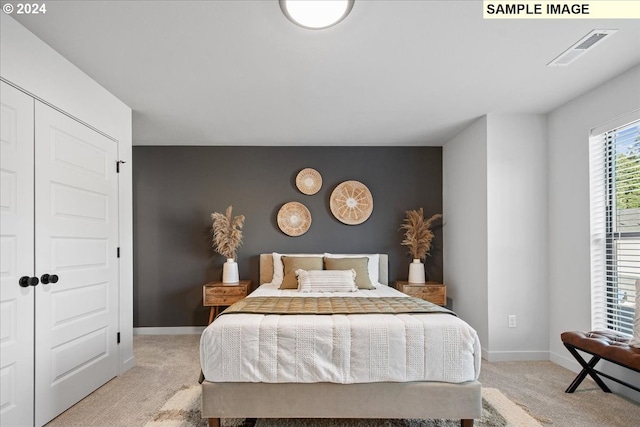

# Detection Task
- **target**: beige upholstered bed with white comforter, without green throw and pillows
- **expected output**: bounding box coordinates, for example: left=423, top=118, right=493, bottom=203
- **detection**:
left=200, top=254, right=482, bottom=427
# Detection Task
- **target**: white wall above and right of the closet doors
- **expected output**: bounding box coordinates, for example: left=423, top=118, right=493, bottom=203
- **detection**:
left=0, top=13, right=135, bottom=372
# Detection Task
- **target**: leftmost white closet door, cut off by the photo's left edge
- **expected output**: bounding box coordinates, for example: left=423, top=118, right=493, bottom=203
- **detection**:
left=0, top=83, right=36, bottom=426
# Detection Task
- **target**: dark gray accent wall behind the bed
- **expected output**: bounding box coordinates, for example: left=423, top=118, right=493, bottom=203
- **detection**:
left=133, top=146, right=442, bottom=327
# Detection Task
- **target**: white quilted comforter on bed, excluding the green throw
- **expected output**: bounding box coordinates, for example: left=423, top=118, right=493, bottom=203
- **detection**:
left=200, top=284, right=480, bottom=384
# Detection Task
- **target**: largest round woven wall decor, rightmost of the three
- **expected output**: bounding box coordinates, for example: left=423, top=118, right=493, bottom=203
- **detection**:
left=329, top=181, right=373, bottom=225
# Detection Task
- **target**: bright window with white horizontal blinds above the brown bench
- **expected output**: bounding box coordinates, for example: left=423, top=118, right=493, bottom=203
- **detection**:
left=589, top=113, right=640, bottom=335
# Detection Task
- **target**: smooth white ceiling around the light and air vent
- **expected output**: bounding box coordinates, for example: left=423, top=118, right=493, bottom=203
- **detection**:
left=12, top=0, right=640, bottom=146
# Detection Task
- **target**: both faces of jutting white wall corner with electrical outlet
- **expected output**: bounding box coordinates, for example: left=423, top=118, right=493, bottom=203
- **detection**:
left=443, top=114, right=549, bottom=361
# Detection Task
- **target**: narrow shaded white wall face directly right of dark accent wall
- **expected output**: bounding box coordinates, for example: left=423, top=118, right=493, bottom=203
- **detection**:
left=442, top=117, right=489, bottom=349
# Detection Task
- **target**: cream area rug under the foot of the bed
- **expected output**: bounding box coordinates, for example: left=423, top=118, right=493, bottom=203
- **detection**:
left=145, top=386, right=548, bottom=427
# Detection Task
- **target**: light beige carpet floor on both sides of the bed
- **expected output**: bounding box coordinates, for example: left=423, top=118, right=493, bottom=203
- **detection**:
left=47, top=335, right=640, bottom=427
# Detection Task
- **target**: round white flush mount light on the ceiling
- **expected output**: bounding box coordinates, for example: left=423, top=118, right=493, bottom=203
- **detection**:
left=280, top=0, right=355, bottom=30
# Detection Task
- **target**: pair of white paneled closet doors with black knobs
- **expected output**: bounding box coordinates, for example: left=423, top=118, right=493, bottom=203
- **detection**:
left=0, top=83, right=119, bottom=427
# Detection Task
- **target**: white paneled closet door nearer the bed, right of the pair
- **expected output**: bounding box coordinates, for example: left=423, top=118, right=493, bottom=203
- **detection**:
left=35, top=101, right=118, bottom=426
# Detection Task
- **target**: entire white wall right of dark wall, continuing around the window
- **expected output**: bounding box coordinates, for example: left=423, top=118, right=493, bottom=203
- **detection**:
left=443, top=66, right=640, bottom=401
